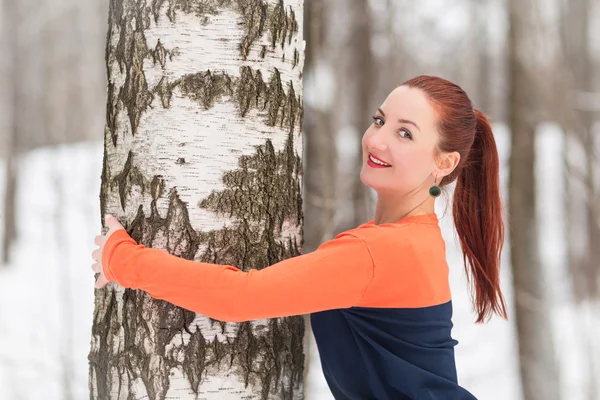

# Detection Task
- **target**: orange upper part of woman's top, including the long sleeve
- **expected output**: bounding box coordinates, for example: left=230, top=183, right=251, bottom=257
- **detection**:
left=102, top=214, right=450, bottom=322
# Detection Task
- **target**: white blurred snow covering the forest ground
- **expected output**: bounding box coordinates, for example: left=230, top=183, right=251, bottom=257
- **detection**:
left=0, top=127, right=600, bottom=400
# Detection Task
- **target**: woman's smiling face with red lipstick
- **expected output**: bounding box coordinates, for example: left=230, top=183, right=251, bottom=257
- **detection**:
left=360, top=86, right=440, bottom=195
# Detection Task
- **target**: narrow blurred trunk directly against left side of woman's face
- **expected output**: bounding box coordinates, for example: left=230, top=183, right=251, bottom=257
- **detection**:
left=346, top=0, right=372, bottom=229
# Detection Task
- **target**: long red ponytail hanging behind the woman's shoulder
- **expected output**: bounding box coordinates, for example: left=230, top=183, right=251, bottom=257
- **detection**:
left=452, top=109, right=507, bottom=323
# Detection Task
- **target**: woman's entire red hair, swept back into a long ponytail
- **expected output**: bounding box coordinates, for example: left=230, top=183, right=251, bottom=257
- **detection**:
left=402, top=75, right=507, bottom=323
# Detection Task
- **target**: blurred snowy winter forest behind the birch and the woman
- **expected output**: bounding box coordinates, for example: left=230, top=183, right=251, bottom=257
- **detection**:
left=0, top=0, right=600, bottom=400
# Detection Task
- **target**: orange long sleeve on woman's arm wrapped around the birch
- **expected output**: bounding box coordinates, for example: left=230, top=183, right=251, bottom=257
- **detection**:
left=102, top=230, right=374, bottom=322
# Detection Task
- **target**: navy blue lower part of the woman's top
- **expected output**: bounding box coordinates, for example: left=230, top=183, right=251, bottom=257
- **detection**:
left=310, top=301, right=475, bottom=400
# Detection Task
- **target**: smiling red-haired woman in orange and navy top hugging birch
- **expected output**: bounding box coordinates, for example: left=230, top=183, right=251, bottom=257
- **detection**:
left=92, top=76, right=506, bottom=400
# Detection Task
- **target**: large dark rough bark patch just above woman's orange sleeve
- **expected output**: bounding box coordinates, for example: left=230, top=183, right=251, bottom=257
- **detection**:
left=198, top=133, right=303, bottom=270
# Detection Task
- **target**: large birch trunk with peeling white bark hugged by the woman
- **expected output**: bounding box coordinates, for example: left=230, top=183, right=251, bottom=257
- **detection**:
left=89, top=0, right=305, bottom=400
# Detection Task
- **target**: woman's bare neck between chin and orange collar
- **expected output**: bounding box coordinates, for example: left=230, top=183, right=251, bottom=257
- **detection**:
left=373, top=195, right=435, bottom=225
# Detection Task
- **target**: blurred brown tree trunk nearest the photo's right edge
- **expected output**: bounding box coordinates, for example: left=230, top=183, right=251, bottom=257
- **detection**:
left=563, top=0, right=600, bottom=301
